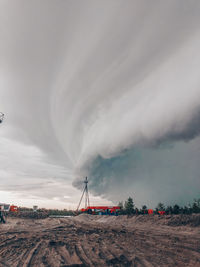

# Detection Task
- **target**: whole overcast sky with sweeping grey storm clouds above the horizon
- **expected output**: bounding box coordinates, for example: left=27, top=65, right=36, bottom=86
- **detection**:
left=0, top=0, right=200, bottom=209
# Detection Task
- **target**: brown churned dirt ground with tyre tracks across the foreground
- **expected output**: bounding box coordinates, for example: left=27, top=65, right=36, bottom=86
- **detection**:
left=0, top=214, right=200, bottom=267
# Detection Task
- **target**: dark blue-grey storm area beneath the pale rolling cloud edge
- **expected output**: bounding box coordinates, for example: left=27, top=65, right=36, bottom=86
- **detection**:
left=77, top=138, right=200, bottom=207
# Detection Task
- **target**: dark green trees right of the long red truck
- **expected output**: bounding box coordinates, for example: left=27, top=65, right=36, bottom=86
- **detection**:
left=118, top=197, right=200, bottom=215
